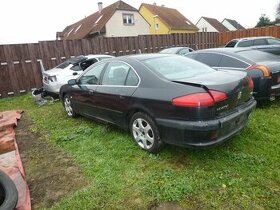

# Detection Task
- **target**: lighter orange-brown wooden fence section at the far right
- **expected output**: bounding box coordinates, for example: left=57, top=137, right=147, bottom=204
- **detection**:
left=219, top=26, right=280, bottom=46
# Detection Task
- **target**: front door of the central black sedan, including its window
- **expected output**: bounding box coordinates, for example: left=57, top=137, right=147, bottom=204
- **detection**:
left=72, top=63, right=106, bottom=117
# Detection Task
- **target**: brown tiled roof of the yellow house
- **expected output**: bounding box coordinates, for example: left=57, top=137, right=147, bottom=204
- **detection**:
left=140, top=3, right=198, bottom=30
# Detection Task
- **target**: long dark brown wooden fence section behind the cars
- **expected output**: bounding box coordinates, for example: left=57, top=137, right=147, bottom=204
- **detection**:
left=0, top=32, right=218, bottom=97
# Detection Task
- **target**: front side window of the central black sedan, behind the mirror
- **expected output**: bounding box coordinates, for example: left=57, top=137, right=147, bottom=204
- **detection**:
left=79, top=63, right=106, bottom=85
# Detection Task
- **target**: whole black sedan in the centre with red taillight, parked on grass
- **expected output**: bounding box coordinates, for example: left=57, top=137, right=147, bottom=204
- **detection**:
left=60, top=54, right=256, bottom=153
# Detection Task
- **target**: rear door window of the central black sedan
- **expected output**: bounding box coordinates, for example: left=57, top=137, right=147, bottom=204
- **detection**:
left=102, top=62, right=130, bottom=86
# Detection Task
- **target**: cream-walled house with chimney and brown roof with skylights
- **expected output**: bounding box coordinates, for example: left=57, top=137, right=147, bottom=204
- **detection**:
left=57, top=1, right=150, bottom=40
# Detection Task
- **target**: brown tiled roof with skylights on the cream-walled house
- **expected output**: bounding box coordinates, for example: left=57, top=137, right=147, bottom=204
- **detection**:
left=62, top=1, right=137, bottom=39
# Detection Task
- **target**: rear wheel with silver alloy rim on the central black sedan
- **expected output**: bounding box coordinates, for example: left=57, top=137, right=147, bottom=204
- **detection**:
left=130, top=112, right=164, bottom=154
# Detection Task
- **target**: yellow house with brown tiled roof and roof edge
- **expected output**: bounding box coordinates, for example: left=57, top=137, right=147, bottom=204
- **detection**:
left=139, top=3, right=198, bottom=34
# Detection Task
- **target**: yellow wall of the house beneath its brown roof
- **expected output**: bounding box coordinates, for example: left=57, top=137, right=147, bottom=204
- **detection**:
left=139, top=6, right=197, bottom=34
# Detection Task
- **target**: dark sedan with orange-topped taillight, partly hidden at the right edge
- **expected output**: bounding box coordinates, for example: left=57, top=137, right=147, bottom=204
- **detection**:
left=186, top=48, right=280, bottom=100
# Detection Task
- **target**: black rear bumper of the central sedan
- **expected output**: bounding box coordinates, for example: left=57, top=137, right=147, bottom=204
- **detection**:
left=156, top=99, right=256, bottom=147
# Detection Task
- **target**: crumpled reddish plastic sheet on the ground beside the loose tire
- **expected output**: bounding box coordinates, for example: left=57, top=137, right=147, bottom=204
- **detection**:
left=0, top=111, right=31, bottom=210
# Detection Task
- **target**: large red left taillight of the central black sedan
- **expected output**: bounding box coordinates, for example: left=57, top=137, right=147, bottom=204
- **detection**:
left=172, top=90, right=227, bottom=107
